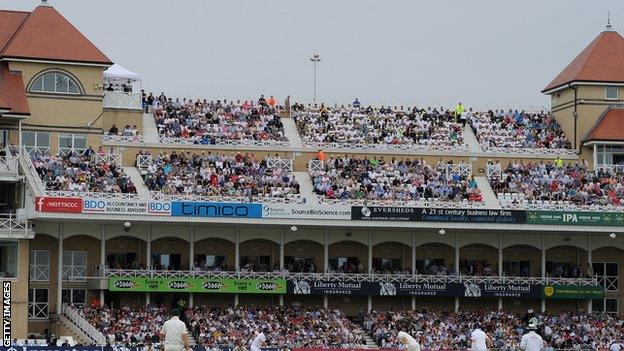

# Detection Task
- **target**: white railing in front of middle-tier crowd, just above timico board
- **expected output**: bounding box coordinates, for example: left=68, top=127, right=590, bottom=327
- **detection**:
left=150, top=190, right=308, bottom=204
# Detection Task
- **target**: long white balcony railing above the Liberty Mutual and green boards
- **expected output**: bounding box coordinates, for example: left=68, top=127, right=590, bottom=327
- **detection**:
left=104, top=269, right=598, bottom=286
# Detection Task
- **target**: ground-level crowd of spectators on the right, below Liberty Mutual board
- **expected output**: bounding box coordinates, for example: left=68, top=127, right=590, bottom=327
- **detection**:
left=361, top=309, right=624, bottom=351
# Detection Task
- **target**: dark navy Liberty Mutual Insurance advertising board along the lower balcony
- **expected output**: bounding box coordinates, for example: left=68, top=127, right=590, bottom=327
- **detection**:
left=287, top=279, right=542, bottom=298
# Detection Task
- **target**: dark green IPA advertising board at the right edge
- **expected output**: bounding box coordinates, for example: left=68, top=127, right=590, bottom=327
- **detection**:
left=527, top=211, right=624, bottom=227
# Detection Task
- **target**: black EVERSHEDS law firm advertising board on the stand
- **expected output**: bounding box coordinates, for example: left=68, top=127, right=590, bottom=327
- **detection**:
left=351, top=206, right=526, bottom=224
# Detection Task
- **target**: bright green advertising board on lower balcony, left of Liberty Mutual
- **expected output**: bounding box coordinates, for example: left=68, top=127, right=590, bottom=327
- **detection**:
left=108, top=277, right=286, bottom=294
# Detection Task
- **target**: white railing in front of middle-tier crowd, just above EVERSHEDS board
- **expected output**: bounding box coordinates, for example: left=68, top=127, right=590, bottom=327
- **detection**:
left=316, top=195, right=485, bottom=208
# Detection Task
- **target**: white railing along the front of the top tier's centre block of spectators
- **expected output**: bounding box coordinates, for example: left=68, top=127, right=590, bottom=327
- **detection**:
left=301, top=140, right=470, bottom=153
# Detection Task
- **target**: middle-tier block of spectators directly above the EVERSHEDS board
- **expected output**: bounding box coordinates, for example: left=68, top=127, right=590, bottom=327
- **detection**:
left=311, top=156, right=482, bottom=202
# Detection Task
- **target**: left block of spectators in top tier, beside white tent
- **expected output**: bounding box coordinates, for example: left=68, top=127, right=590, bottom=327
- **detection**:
left=151, top=93, right=287, bottom=145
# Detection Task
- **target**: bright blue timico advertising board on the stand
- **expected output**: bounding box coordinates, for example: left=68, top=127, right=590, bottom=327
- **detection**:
left=171, top=201, right=262, bottom=218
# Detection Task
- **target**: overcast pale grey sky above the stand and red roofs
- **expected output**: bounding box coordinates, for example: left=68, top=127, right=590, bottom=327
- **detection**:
left=0, top=0, right=624, bottom=107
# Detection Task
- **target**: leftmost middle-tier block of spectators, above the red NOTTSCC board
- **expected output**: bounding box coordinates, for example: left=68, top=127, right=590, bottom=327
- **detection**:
left=31, top=147, right=136, bottom=193
